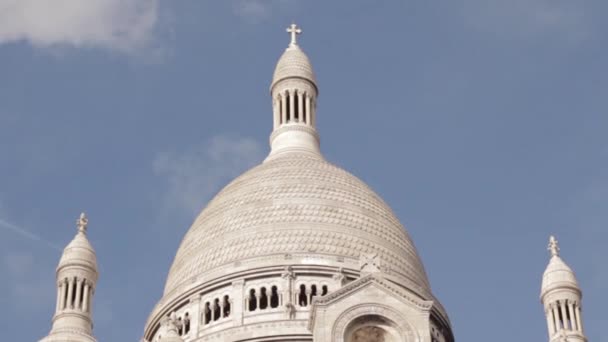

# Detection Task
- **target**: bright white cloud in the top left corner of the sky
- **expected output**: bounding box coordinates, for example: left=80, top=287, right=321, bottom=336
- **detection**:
left=0, top=0, right=159, bottom=52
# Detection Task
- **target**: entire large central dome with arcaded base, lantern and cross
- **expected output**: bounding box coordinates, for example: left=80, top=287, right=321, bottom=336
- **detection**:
left=144, top=25, right=453, bottom=342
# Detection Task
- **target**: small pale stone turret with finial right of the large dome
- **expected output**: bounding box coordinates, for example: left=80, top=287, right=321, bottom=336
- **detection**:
left=540, top=236, right=587, bottom=342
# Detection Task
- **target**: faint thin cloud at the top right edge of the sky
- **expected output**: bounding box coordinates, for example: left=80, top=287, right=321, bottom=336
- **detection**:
left=464, top=0, right=589, bottom=40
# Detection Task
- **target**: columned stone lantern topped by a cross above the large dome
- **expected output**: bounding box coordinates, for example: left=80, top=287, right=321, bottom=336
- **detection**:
left=269, top=24, right=320, bottom=159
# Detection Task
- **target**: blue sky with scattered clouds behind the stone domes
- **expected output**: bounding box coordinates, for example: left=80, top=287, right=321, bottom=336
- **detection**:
left=0, top=0, right=608, bottom=342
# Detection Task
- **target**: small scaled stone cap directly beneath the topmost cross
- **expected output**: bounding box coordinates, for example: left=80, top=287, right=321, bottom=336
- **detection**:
left=271, top=45, right=316, bottom=88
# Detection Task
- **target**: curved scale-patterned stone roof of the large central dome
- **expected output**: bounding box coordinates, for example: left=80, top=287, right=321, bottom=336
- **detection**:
left=165, top=152, right=430, bottom=295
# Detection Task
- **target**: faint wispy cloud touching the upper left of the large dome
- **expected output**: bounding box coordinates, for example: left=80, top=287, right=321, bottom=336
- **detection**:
left=153, top=135, right=262, bottom=215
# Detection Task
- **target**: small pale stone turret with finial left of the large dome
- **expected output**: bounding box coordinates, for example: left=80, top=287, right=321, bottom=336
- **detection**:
left=41, top=213, right=98, bottom=342
